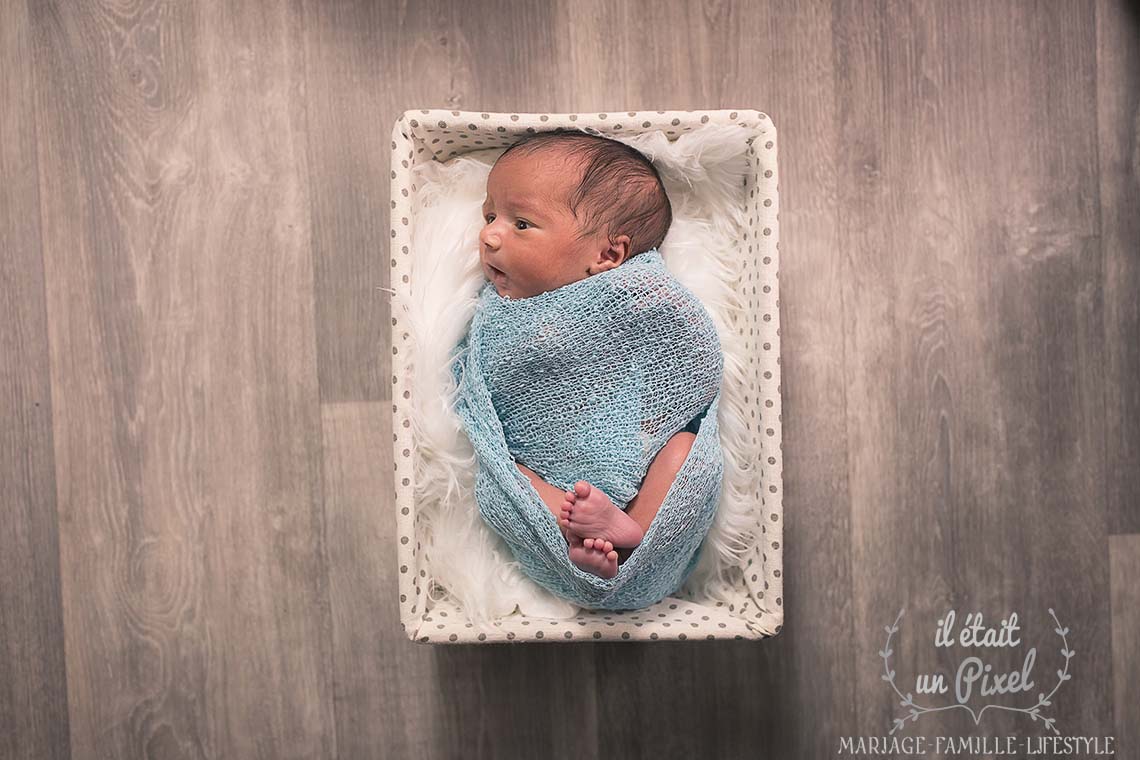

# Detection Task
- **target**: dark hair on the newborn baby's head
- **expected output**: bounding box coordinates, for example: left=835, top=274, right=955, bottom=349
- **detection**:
left=499, top=129, right=673, bottom=258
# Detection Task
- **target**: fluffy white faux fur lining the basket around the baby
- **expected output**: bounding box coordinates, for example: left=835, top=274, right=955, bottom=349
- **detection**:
left=392, top=124, right=759, bottom=626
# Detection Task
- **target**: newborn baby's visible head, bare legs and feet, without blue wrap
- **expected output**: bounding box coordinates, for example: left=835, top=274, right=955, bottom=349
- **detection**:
left=479, top=130, right=699, bottom=578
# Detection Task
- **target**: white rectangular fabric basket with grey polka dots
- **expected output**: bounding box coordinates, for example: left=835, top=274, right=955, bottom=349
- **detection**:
left=390, top=109, right=783, bottom=644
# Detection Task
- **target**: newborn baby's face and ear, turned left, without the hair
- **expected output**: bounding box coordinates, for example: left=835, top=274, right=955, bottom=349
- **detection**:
left=479, top=153, right=625, bottom=299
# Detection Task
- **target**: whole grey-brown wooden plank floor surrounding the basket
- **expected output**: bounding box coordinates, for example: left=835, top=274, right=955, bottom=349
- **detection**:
left=0, top=0, right=1140, bottom=760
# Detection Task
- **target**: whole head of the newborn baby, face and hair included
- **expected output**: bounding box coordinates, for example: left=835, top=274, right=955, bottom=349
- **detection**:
left=479, top=130, right=673, bottom=299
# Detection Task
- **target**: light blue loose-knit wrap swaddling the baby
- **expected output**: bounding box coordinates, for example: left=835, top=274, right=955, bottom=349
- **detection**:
left=451, top=248, right=724, bottom=610
